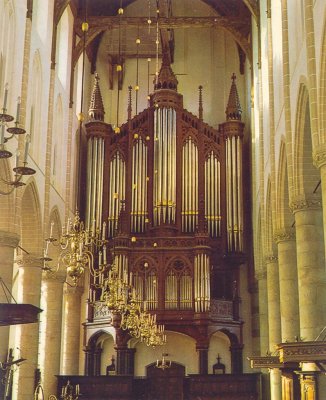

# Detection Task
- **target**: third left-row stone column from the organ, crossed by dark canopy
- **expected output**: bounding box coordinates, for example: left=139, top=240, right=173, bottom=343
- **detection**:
left=13, top=255, right=42, bottom=400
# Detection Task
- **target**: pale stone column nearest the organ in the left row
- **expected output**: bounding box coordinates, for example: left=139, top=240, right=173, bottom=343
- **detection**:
left=61, top=284, right=83, bottom=375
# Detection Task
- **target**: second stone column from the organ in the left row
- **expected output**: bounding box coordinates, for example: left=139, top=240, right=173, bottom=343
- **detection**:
left=39, top=273, right=64, bottom=398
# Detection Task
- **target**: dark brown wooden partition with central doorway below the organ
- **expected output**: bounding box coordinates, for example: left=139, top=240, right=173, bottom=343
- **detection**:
left=58, top=374, right=260, bottom=400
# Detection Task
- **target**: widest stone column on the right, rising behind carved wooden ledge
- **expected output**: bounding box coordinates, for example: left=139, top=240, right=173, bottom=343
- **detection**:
left=291, top=197, right=326, bottom=340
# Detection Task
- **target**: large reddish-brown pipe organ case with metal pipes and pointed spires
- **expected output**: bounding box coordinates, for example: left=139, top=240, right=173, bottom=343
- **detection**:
left=84, top=59, right=244, bottom=312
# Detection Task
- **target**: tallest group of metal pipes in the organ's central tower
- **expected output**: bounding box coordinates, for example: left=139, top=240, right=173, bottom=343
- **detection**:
left=153, top=107, right=176, bottom=226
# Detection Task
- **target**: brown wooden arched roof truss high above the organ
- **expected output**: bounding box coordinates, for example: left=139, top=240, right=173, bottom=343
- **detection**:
left=64, top=0, right=259, bottom=70
